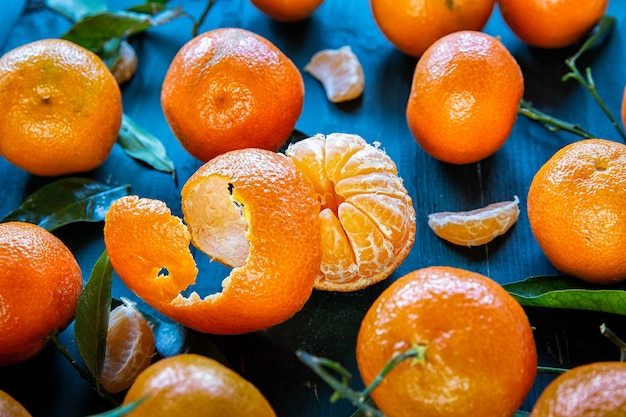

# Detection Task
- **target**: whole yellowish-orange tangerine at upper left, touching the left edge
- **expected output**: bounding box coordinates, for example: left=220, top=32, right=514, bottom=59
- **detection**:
left=0, top=39, right=122, bottom=176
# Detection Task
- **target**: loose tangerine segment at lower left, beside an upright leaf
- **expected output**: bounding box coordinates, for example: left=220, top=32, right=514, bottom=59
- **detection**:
left=99, top=301, right=155, bottom=393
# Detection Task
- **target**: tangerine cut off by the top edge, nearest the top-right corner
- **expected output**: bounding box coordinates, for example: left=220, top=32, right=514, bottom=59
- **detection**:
left=498, top=0, right=609, bottom=48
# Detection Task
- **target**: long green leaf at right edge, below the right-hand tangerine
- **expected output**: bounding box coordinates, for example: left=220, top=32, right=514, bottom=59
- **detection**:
left=503, top=275, right=626, bottom=315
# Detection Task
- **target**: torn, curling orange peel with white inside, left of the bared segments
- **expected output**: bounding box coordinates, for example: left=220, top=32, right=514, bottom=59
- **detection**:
left=104, top=148, right=321, bottom=334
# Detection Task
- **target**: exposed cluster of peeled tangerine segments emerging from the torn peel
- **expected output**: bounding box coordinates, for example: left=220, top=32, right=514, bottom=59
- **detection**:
left=286, top=133, right=415, bottom=291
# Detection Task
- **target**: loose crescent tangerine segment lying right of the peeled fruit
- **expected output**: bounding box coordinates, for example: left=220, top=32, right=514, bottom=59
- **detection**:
left=428, top=196, right=519, bottom=246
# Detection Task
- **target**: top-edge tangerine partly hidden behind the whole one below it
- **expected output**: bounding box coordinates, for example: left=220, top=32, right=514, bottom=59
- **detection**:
left=370, top=0, right=495, bottom=57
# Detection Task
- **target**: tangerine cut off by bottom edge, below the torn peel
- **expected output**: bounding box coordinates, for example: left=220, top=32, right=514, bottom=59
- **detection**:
left=124, top=353, right=276, bottom=417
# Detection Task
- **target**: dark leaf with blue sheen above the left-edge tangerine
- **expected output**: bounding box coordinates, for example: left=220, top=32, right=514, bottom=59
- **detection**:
left=0, top=177, right=130, bottom=231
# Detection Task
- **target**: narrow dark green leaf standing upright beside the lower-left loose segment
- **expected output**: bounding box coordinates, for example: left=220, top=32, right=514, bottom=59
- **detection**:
left=74, top=251, right=113, bottom=381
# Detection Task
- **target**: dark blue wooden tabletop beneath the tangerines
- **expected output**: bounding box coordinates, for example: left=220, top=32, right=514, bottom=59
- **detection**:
left=0, top=0, right=626, bottom=417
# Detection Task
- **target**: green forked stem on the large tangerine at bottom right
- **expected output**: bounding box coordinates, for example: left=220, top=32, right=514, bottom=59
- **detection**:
left=296, top=343, right=427, bottom=417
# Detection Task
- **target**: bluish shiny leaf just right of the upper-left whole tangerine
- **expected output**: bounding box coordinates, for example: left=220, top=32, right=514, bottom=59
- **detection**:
left=117, top=115, right=176, bottom=175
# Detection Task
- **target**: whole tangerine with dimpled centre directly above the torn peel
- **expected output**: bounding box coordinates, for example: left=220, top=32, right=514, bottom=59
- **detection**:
left=161, top=28, right=304, bottom=161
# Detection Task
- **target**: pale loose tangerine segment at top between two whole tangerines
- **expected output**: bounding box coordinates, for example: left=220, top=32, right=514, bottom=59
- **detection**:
left=304, top=46, right=365, bottom=103
